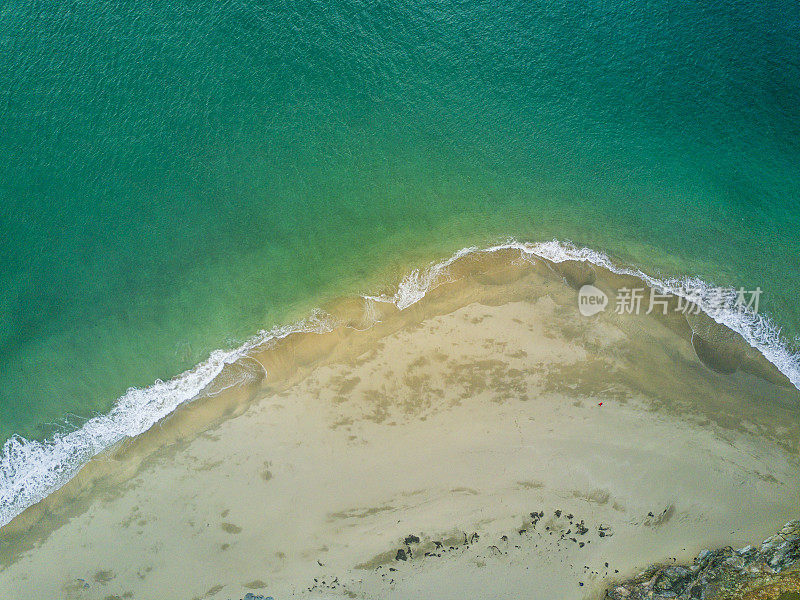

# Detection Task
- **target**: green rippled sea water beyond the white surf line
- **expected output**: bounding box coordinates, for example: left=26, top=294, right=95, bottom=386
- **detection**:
left=0, top=0, right=800, bottom=450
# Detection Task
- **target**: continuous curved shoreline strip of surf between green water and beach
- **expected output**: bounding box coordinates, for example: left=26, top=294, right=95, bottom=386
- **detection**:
left=0, top=240, right=800, bottom=528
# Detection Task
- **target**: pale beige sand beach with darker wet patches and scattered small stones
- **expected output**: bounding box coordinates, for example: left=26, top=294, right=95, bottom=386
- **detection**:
left=0, top=251, right=800, bottom=600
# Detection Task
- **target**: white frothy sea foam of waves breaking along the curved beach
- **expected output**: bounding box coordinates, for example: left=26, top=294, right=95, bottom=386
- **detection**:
left=0, top=240, right=800, bottom=526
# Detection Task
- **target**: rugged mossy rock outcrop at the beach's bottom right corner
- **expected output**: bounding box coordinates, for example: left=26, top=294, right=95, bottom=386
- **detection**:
left=606, top=520, right=800, bottom=600
